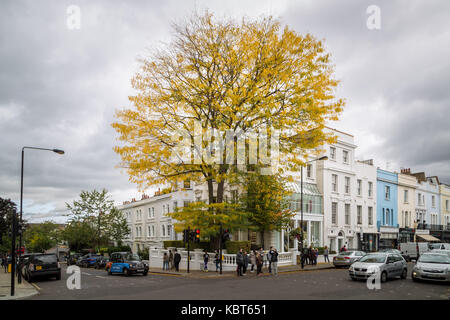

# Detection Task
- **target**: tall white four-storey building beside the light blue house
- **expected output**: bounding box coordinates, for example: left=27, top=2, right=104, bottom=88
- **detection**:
left=317, top=128, right=378, bottom=252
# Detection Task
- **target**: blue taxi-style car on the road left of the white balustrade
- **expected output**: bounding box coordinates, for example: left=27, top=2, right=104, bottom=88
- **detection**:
left=108, top=252, right=148, bottom=276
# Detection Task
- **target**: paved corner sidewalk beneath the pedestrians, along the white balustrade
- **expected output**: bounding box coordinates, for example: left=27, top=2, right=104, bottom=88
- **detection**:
left=149, top=262, right=334, bottom=279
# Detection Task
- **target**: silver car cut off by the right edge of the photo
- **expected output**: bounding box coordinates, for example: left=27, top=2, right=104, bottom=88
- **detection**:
left=412, top=252, right=450, bottom=282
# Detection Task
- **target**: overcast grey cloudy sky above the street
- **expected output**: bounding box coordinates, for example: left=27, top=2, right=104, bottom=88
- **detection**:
left=0, top=0, right=450, bottom=221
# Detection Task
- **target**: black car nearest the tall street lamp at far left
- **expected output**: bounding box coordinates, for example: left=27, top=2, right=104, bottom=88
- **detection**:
left=22, top=253, right=61, bottom=281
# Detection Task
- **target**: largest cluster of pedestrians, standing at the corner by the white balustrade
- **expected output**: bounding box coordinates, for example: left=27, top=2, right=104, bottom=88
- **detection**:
left=236, top=247, right=278, bottom=277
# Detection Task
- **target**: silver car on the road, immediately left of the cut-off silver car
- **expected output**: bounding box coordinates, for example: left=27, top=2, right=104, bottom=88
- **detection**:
left=348, top=252, right=408, bottom=282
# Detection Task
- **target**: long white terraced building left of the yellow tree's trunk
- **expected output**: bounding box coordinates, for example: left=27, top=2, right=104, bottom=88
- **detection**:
left=118, top=183, right=194, bottom=252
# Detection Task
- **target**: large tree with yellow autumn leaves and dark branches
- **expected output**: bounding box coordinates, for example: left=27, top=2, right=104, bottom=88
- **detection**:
left=112, top=12, right=344, bottom=235
